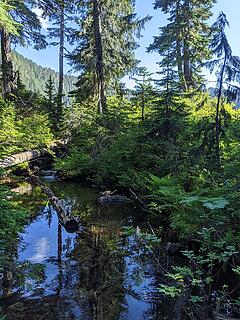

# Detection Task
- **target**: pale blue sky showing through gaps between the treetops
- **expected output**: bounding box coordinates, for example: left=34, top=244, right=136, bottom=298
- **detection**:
left=17, top=0, right=240, bottom=86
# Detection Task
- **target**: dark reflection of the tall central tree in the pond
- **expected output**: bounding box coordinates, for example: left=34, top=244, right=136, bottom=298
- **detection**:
left=79, top=227, right=125, bottom=320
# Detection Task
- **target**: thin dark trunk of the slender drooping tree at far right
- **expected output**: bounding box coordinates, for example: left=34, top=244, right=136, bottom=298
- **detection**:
left=215, top=55, right=227, bottom=171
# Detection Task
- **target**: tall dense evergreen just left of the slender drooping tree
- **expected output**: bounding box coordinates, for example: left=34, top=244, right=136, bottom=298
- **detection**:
left=148, top=0, right=216, bottom=91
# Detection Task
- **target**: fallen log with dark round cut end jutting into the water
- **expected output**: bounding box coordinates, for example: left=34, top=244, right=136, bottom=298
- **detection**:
left=27, top=169, right=79, bottom=233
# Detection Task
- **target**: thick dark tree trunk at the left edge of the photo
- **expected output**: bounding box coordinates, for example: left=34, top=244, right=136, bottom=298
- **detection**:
left=1, top=29, right=16, bottom=99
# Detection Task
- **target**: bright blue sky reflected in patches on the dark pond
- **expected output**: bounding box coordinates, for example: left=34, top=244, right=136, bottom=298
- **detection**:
left=15, top=184, right=158, bottom=320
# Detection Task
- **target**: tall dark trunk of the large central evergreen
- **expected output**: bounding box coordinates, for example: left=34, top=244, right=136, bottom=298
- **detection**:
left=93, top=0, right=107, bottom=113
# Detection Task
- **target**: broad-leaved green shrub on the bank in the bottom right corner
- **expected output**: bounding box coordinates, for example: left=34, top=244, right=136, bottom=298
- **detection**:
left=159, top=228, right=239, bottom=317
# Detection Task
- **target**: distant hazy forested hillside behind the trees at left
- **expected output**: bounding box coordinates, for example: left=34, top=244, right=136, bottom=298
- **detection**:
left=13, top=51, right=77, bottom=94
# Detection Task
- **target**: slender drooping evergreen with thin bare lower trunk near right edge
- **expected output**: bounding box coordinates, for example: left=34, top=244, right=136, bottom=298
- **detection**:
left=207, top=12, right=240, bottom=169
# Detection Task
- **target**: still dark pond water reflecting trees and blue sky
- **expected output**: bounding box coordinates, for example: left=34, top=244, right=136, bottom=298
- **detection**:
left=0, top=181, right=173, bottom=320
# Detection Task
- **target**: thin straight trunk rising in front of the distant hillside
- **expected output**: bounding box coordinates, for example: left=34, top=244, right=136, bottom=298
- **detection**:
left=57, top=1, right=65, bottom=121
